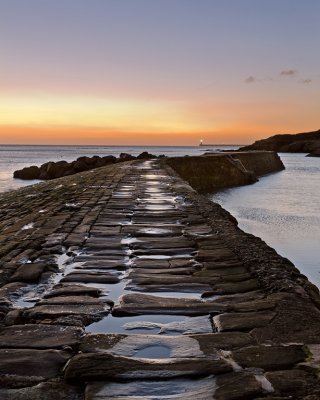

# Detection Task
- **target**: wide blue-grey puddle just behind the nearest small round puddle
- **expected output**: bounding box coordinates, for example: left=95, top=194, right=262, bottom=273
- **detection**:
left=86, top=314, right=186, bottom=335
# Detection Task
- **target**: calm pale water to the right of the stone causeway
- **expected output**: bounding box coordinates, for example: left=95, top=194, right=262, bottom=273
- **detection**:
left=211, top=154, right=320, bottom=288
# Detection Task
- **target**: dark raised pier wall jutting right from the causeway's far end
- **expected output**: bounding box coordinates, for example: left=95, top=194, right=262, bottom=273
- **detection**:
left=165, top=151, right=284, bottom=193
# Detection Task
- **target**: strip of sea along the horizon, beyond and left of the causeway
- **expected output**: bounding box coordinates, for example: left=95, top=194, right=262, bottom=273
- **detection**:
left=0, top=145, right=237, bottom=192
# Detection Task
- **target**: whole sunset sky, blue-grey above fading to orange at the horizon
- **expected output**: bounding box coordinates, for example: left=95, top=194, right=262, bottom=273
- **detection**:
left=0, top=0, right=320, bottom=145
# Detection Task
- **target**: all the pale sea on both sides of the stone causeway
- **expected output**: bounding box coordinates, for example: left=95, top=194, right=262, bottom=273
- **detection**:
left=0, top=145, right=320, bottom=288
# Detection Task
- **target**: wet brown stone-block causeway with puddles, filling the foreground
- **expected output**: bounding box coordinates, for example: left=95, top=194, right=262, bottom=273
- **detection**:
left=0, top=160, right=320, bottom=400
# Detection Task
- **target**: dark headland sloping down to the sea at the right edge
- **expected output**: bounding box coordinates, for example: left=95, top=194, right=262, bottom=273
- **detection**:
left=239, top=129, right=320, bottom=153
